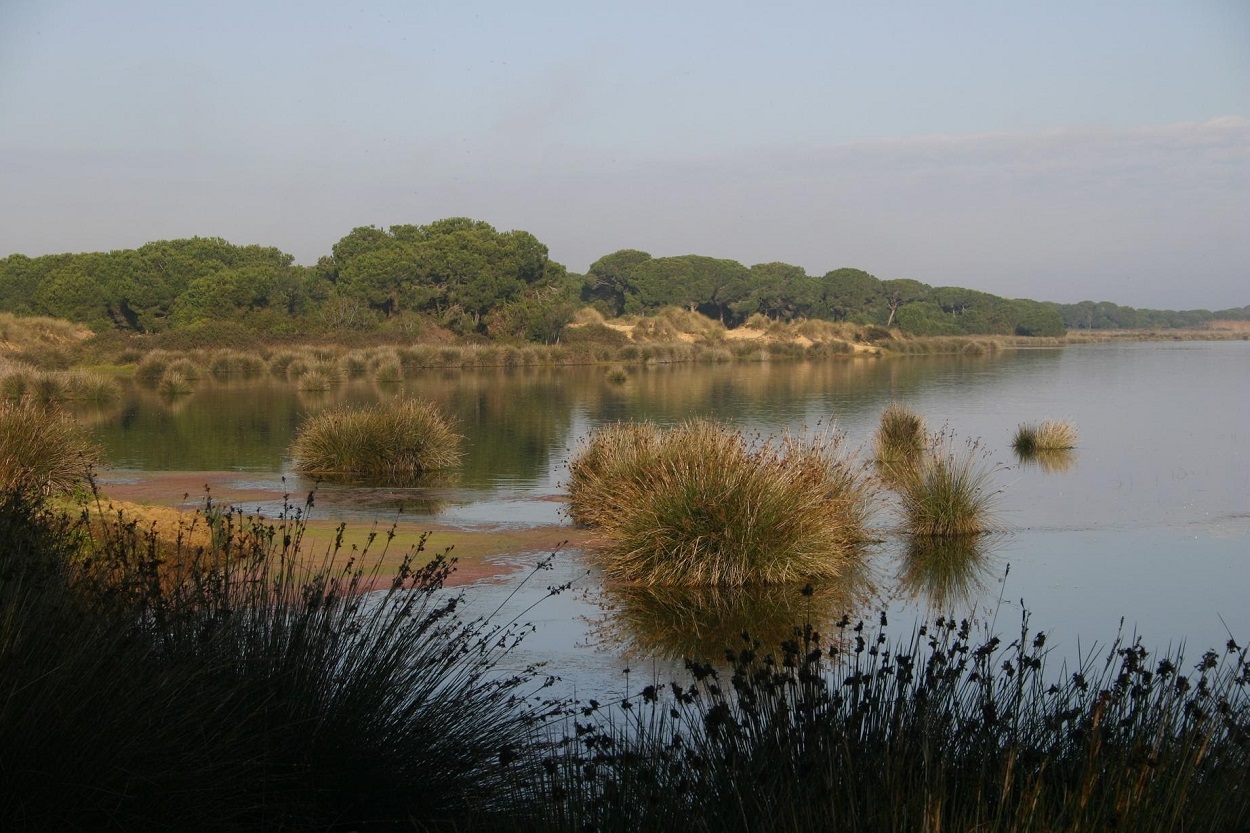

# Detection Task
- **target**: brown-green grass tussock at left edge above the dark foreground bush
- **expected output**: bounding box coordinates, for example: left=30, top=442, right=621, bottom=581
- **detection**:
left=0, top=401, right=101, bottom=495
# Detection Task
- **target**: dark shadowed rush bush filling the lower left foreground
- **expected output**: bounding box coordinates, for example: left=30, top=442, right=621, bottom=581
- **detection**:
left=0, top=494, right=547, bottom=830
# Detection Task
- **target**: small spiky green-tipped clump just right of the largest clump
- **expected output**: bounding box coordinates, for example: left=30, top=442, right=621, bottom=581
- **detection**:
left=893, top=432, right=999, bottom=537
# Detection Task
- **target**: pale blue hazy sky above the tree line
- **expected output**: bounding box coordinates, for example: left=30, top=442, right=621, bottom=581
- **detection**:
left=0, top=0, right=1250, bottom=309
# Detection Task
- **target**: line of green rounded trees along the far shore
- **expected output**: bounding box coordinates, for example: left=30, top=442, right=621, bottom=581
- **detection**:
left=0, top=218, right=1250, bottom=343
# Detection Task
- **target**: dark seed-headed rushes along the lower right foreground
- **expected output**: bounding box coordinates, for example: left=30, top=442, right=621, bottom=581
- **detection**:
left=529, top=614, right=1250, bottom=833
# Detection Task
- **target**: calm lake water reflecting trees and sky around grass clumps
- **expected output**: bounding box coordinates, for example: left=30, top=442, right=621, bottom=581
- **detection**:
left=96, top=341, right=1250, bottom=684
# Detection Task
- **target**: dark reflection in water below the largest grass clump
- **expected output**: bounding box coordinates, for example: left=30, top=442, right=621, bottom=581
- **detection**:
left=595, top=563, right=875, bottom=659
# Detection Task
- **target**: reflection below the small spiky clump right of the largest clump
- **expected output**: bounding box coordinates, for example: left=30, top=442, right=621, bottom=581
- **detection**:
left=898, top=535, right=999, bottom=613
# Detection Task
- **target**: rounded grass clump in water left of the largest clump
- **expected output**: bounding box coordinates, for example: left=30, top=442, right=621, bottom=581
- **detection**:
left=291, top=399, right=461, bottom=484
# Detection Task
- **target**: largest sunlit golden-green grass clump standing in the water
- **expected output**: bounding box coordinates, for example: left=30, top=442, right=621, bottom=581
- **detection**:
left=569, top=419, right=870, bottom=587
